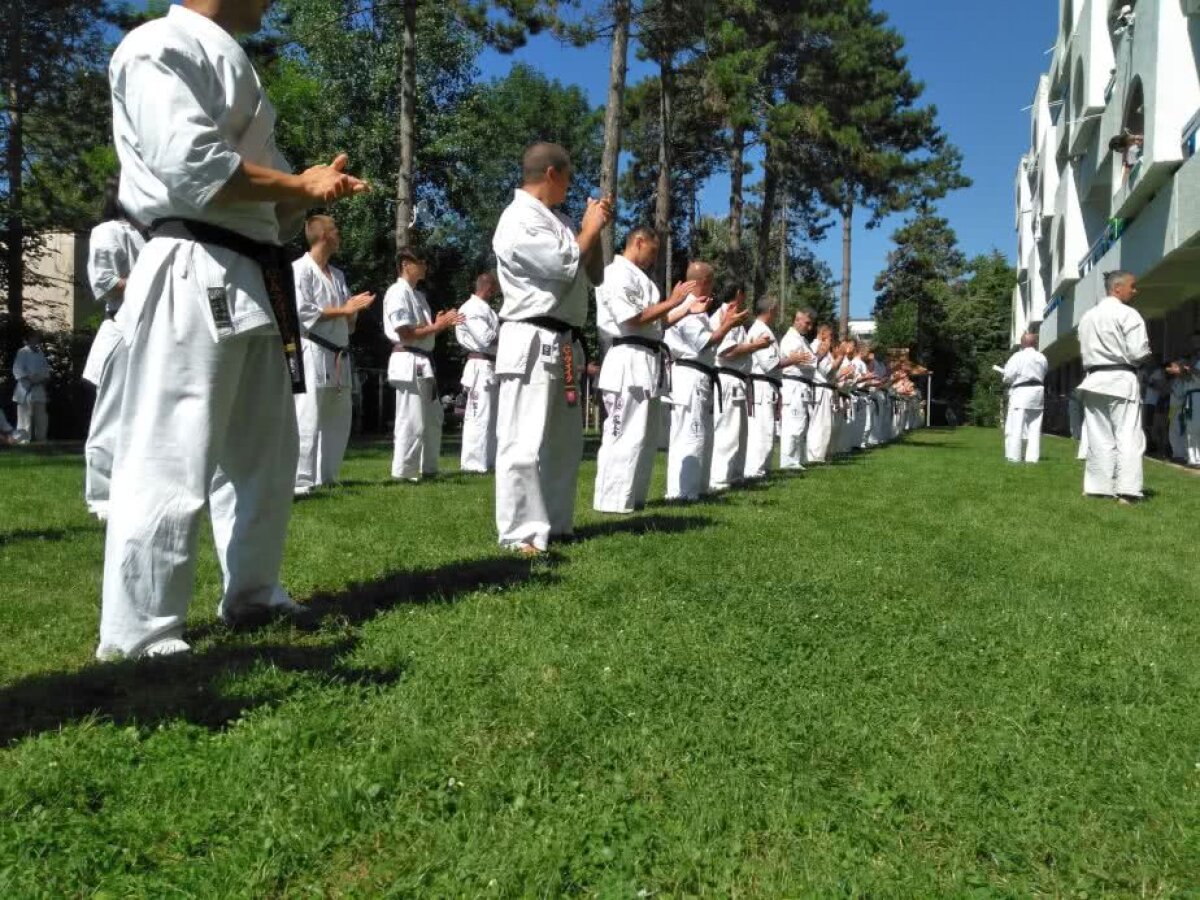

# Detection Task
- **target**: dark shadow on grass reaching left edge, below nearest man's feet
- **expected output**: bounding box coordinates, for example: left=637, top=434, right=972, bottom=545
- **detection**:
left=0, top=640, right=402, bottom=745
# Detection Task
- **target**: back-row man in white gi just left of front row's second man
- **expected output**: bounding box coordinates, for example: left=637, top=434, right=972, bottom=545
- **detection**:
left=455, top=272, right=500, bottom=474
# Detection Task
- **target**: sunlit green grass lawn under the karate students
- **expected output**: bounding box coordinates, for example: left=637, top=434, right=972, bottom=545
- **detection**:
left=0, top=430, right=1200, bottom=898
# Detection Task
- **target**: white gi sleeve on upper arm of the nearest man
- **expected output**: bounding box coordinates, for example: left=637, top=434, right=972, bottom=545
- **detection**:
left=113, top=48, right=241, bottom=209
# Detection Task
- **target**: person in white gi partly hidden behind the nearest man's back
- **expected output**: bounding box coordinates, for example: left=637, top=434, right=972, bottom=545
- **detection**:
left=83, top=178, right=145, bottom=521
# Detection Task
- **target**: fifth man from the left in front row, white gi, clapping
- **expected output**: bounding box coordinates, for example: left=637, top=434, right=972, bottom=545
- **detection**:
left=708, top=287, right=769, bottom=492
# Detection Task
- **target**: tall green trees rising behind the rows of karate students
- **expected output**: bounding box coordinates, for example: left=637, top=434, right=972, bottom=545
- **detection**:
left=0, top=0, right=1010, bottom=436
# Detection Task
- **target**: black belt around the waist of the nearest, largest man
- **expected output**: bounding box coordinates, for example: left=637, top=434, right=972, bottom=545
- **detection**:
left=150, top=216, right=305, bottom=394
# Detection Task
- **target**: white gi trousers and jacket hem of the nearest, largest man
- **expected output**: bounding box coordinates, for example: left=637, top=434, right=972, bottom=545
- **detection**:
left=96, top=240, right=296, bottom=659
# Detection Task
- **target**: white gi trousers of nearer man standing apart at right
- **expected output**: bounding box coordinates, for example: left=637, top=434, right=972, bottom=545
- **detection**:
left=1082, top=391, right=1146, bottom=497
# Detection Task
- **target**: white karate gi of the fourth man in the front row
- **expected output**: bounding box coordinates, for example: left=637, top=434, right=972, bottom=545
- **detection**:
left=664, top=301, right=716, bottom=500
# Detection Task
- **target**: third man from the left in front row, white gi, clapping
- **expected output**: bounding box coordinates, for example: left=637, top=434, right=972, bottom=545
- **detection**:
left=593, top=226, right=695, bottom=514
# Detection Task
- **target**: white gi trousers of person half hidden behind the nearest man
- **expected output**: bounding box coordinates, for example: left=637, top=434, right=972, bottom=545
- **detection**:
left=83, top=319, right=128, bottom=518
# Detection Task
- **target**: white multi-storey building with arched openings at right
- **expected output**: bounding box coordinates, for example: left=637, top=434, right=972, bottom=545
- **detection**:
left=1013, top=0, right=1200, bottom=429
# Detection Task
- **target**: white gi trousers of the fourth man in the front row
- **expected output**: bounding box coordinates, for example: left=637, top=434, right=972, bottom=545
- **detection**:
left=666, top=366, right=713, bottom=500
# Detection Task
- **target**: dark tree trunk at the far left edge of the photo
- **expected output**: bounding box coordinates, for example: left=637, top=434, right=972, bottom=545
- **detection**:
left=5, top=2, right=25, bottom=350
